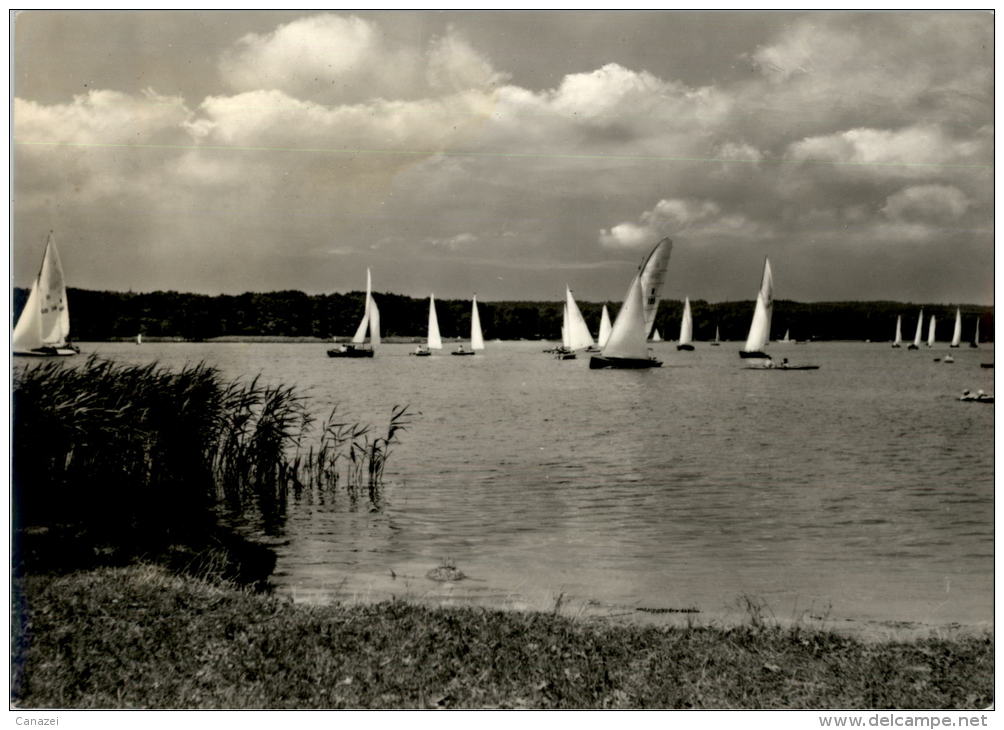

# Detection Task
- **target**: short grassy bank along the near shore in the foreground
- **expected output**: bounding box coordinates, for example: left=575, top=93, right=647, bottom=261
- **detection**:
left=14, top=566, right=993, bottom=708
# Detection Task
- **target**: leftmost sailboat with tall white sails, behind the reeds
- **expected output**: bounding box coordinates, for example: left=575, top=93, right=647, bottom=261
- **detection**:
left=12, top=232, right=80, bottom=357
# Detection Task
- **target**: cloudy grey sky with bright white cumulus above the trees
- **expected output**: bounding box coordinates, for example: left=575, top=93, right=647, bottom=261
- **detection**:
left=11, top=11, right=994, bottom=304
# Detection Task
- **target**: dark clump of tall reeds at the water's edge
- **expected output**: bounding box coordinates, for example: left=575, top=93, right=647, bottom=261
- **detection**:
left=12, top=356, right=413, bottom=568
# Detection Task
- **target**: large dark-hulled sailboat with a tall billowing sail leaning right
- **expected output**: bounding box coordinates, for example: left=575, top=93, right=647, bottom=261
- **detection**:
left=589, top=238, right=673, bottom=370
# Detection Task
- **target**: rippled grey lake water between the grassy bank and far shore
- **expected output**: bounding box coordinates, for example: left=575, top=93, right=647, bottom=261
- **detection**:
left=74, top=342, right=994, bottom=625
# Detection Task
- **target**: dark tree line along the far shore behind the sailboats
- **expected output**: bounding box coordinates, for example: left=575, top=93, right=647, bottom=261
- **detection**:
left=12, top=288, right=994, bottom=341
